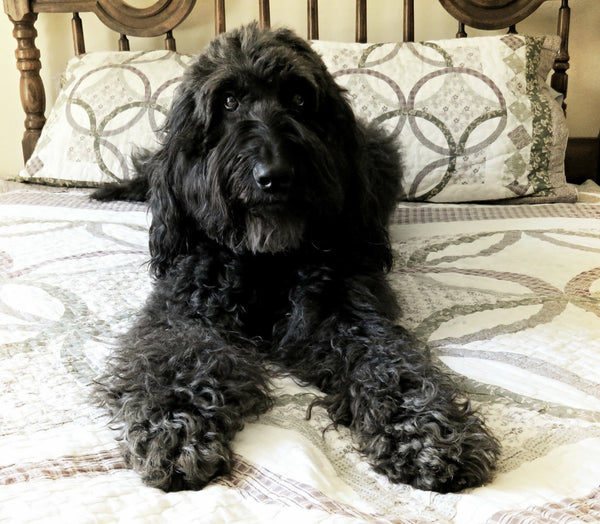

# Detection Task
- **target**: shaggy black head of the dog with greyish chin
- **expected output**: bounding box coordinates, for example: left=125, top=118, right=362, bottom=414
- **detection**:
left=145, top=24, right=398, bottom=274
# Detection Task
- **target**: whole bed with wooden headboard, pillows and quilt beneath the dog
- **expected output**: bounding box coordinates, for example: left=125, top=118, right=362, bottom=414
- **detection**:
left=0, top=0, right=600, bottom=523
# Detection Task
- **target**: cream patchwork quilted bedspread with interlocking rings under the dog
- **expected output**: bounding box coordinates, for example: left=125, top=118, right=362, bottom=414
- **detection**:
left=0, top=191, right=600, bottom=524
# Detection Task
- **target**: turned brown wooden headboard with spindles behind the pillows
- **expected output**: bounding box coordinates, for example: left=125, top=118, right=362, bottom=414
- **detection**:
left=4, top=0, right=577, bottom=181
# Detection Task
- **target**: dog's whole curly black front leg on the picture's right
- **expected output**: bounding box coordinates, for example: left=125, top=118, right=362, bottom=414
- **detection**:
left=280, top=276, right=499, bottom=492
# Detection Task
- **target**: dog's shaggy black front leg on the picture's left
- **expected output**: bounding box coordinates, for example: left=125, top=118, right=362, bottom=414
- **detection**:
left=99, top=304, right=270, bottom=491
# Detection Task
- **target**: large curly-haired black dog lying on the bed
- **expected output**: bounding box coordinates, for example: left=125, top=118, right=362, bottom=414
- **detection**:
left=92, top=25, right=499, bottom=491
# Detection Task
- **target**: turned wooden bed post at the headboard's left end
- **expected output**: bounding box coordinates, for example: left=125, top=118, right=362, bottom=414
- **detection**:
left=9, top=13, right=46, bottom=162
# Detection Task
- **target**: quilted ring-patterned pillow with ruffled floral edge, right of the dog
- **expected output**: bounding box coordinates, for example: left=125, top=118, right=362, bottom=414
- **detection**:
left=313, top=35, right=576, bottom=203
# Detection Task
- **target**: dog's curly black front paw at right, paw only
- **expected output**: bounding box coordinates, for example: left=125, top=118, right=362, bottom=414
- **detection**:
left=360, top=412, right=500, bottom=493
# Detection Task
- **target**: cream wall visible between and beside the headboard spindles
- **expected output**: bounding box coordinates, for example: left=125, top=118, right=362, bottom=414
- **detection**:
left=0, top=0, right=600, bottom=177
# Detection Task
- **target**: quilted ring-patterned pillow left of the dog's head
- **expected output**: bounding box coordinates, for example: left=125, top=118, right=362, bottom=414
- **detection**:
left=20, top=51, right=192, bottom=186
